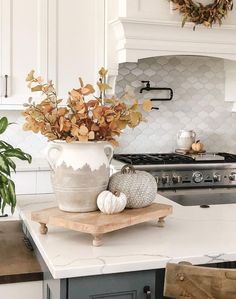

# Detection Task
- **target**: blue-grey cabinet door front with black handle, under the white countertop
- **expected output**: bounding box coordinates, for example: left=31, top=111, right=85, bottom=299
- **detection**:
left=68, top=271, right=155, bottom=299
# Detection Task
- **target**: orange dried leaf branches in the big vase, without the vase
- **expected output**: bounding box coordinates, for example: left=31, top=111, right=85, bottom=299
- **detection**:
left=23, top=68, right=152, bottom=145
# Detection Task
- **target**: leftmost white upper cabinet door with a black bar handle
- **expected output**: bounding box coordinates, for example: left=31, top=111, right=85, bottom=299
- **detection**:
left=0, top=0, right=44, bottom=109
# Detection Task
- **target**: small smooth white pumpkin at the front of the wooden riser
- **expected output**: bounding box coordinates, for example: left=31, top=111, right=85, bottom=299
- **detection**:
left=97, top=190, right=127, bottom=214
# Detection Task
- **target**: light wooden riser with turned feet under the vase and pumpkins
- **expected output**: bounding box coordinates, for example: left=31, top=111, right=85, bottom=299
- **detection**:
left=31, top=203, right=172, bottom=246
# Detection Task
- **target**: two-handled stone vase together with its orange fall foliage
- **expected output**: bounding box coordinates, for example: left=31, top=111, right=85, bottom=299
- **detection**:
left=23, top=68, right=152, bottom=212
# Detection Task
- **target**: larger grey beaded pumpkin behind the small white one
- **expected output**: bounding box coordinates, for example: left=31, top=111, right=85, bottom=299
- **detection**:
left=108, top=165, right=157, bottom=208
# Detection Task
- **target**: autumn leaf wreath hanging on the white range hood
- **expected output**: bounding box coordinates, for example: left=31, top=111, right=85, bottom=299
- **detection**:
left=169, top=0, right=233, bottom=30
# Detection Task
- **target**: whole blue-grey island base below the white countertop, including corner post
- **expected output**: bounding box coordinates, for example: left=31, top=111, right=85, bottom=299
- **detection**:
left=44, top=270, right=159, bottom=299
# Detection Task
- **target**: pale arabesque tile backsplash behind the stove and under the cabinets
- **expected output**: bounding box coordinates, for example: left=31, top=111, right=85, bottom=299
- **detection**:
left=1, top=56, right=236, bottom=157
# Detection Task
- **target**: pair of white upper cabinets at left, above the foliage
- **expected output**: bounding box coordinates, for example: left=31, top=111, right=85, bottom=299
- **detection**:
left=0, top=0, right=105, bottom=110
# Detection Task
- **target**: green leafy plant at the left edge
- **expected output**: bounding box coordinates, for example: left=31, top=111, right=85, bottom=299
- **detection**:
left=0, top=117, right=31, bottom=215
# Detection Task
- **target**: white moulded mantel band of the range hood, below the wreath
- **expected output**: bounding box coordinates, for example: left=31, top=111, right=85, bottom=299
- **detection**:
left=110, top=18, right=236, bottom=63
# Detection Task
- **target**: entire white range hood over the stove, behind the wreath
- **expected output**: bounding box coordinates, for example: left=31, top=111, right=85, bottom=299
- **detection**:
left=106, top=0, right=236, bottom=110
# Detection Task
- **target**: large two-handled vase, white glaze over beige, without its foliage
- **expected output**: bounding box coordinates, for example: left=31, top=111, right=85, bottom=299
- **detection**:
left=47, top=140, right=113, bottom=212
